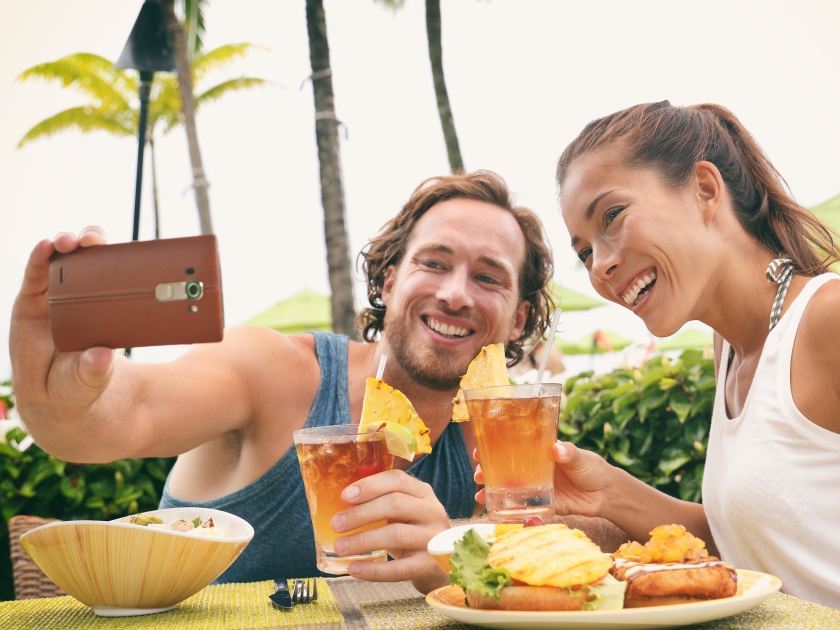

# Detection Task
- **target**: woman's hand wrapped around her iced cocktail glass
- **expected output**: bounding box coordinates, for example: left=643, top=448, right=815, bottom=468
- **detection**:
left=473, top=441, right=615, bottom=516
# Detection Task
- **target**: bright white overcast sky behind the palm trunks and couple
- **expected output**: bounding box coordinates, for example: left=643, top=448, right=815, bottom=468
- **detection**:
left=0, top=0, right=840, bottom=380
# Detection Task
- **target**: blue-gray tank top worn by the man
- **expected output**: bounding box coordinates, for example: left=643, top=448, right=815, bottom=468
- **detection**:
left=160, top=332, right=475, bottom=583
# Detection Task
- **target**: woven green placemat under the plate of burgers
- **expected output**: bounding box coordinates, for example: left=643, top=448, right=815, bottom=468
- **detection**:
left=358, top=593, right=840, bottom=630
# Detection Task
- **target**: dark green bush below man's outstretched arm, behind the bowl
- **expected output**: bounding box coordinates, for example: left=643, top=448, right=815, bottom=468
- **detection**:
left=0, top=383, right=175, bottom=600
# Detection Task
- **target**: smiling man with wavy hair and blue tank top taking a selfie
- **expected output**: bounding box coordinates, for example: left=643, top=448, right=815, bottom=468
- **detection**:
left=9, top=172, right=620, bottom=591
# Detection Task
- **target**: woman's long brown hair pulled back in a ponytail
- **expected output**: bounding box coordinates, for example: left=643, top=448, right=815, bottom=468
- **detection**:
left=557, top=101, right=840, bottom=276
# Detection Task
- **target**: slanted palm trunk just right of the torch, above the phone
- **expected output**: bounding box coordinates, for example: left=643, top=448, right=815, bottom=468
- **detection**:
left=161, top=0, right=213, bottom=234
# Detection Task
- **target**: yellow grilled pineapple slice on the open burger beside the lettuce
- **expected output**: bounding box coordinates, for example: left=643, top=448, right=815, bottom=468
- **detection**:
left=487, top=524, right=613, bottom=587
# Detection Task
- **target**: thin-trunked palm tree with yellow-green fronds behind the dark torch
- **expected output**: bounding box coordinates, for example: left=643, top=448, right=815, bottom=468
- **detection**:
left=17, top=43, right=269, bottom=237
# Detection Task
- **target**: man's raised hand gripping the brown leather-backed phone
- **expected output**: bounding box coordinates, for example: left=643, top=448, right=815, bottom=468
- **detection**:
left=9, top=226, right=114, bottom=429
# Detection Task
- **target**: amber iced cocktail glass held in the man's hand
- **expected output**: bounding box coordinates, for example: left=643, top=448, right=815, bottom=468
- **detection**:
left=293, top=424, right=394, bottom=575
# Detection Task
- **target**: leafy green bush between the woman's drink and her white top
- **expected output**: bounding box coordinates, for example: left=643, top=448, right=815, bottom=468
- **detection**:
left=559, top=350, right=715, bottom=503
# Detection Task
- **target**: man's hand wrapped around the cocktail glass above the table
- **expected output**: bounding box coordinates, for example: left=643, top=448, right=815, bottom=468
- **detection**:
left=330, top=470, right=449, bottom=593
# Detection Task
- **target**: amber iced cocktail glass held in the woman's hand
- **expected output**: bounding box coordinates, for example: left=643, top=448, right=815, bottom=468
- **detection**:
left=464, top=383, right=562, bottom=523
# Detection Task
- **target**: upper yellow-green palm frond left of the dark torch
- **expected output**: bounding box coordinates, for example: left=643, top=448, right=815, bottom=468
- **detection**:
left=16, top=53, right=137, bottom=108
